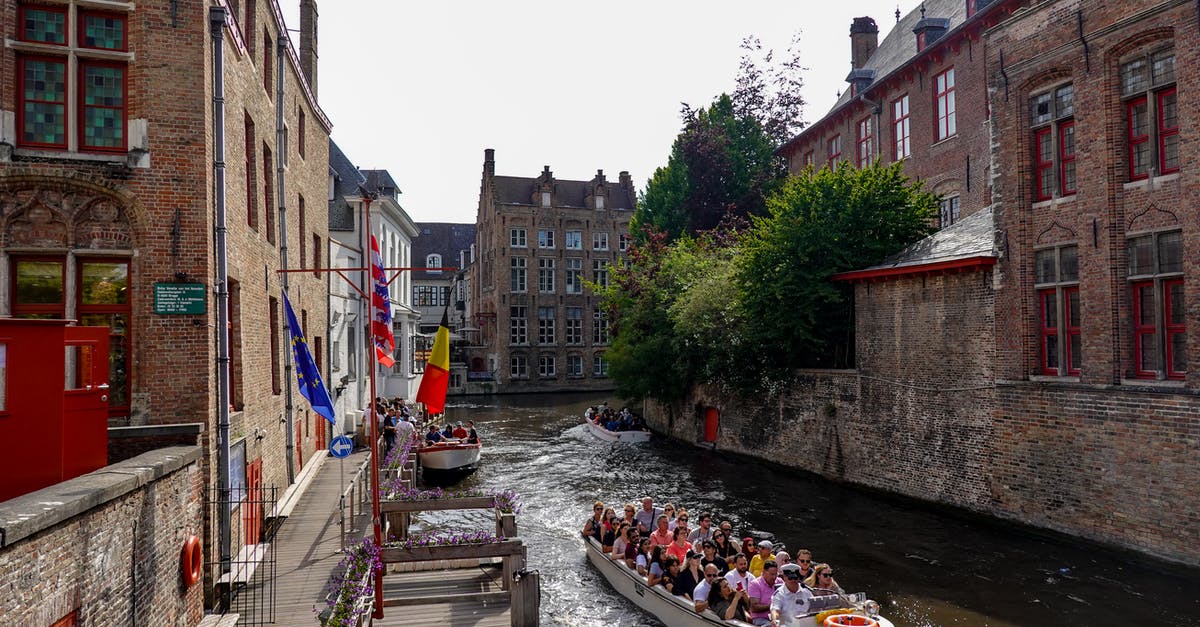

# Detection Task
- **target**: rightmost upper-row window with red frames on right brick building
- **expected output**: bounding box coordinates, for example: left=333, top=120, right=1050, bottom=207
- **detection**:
left=1121, top=48, right=1180, bottom=180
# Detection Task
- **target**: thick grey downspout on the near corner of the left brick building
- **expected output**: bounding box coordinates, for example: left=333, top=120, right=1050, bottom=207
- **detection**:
left=209, top=6, right=233, bottom=574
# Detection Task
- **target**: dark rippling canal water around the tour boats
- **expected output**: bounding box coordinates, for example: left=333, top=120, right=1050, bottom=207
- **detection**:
left=415, top=395, right=1200, bottom=627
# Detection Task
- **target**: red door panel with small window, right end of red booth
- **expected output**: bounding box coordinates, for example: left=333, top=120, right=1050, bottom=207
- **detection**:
left=62, top=327, right=110, bottom=479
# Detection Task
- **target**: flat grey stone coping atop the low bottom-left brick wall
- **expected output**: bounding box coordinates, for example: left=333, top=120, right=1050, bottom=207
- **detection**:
left=0, top=447, right=202, bottom=547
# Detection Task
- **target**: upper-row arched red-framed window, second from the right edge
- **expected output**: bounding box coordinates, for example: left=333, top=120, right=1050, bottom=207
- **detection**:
left=1030, top=84, right=1075, bottom=201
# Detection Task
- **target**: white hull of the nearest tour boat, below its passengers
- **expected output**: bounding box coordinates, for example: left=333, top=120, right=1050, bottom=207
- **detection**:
left=584, top=537, right=894, bottom=627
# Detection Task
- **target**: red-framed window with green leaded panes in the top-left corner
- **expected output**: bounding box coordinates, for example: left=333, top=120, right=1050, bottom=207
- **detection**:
left=10, top=5, right=131, bottom=153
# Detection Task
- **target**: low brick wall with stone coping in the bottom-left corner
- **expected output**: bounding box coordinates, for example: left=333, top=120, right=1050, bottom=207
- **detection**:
left=0, top=446, right=204, bottom=627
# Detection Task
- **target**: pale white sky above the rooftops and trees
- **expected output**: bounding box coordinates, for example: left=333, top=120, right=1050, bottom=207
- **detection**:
left=280, top=0, right=919, bottom=222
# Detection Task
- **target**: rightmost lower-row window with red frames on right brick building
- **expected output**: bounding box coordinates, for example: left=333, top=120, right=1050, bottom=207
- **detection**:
left=1129, top=231, right=1188, bottom=380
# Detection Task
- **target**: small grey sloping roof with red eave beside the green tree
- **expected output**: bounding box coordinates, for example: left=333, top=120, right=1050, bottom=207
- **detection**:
left=834, top=207, right=996, bottom=281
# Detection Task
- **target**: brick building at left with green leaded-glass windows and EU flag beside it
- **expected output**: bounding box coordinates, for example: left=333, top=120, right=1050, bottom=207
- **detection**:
left=0, top=0, right=330, bottom=586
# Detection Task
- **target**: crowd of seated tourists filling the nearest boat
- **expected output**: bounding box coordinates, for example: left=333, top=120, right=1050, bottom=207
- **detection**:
left=582, top=496, right=845, bottom=627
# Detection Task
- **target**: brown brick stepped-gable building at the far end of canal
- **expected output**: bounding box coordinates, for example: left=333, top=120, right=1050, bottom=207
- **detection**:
left=469, top=149, right=636, bottom=392
